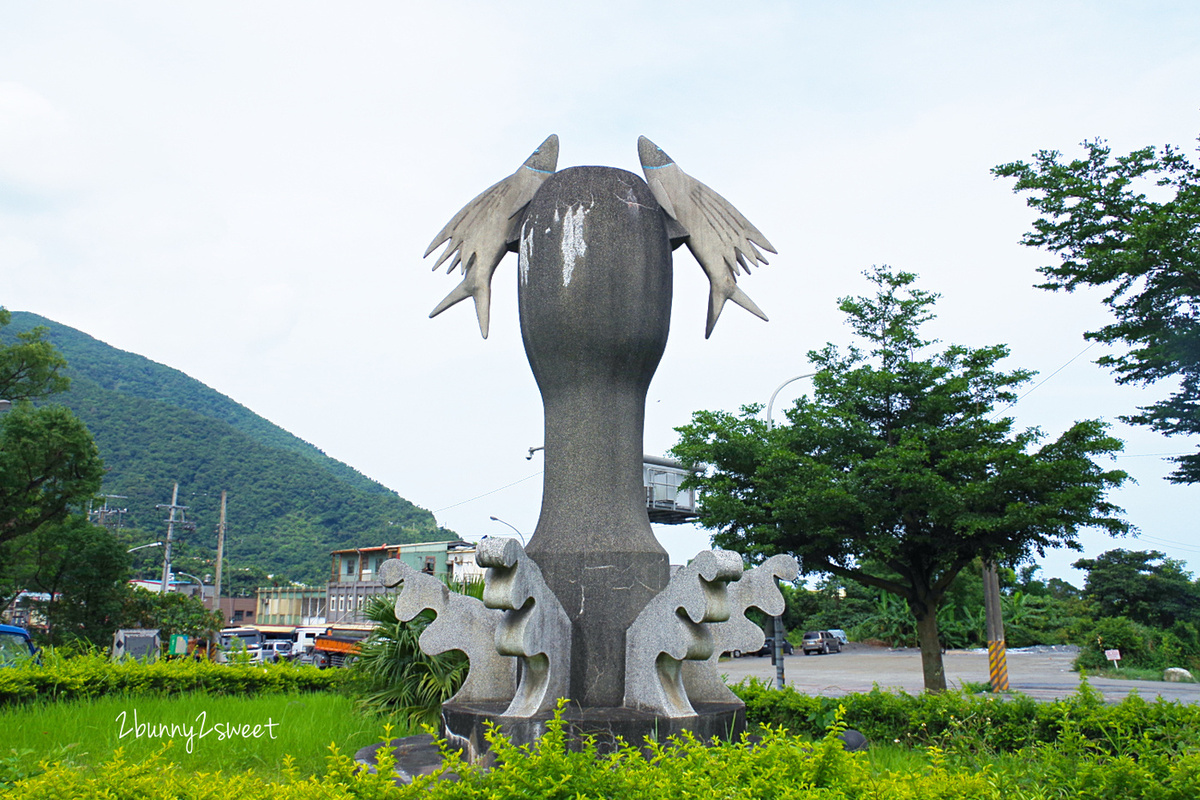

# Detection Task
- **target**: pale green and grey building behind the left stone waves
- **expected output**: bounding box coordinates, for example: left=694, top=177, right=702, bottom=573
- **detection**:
left=328, top=540, right=482, bottom=625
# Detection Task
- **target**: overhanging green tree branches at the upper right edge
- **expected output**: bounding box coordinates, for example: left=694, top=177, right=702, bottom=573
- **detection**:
left=992, top=139, right=1200, bottom=483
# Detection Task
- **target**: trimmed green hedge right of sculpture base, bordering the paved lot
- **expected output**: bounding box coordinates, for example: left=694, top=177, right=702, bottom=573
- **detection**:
left=733, top=679, right=1200, bottom=758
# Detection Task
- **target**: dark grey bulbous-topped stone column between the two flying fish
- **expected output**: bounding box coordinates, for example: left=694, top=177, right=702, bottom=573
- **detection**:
left=517, top=167, right=671, bottom=706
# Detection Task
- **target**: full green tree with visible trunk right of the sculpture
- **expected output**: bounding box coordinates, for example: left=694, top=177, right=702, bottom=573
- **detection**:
left=673, top=267, right=1129, bottom=691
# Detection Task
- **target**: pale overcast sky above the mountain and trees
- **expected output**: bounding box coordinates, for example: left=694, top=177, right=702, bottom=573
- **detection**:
left=0, top=0, right=1200, bottom=584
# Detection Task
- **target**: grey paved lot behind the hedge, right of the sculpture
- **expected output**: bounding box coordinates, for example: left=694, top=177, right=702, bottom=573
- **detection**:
left=719, top=644, right=1200, bottom=703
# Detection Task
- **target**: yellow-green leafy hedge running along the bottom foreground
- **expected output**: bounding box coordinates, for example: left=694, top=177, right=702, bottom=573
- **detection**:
left=11, top=705, right=1200, bottom=800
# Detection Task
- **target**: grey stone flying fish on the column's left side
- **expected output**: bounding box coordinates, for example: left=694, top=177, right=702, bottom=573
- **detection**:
left=425, top=134, right=558, bottom=339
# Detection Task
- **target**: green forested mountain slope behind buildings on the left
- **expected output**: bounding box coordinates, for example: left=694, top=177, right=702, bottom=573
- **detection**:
left=7, top=311, right=455, bottom=584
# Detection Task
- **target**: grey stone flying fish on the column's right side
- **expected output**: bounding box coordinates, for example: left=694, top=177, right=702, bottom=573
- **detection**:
left=637, top=137, right=776, bottom=338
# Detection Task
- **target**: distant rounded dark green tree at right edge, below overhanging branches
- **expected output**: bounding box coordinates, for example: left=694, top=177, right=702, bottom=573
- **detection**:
left=1073, top=548, right=1200, bottom=628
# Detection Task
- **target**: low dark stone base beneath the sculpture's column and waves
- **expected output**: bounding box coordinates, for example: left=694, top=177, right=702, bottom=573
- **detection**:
left=442, top=700, right=746, bottom=765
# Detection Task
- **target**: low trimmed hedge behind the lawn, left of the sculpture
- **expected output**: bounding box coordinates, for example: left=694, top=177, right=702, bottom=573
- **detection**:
left=0, top=654, right=347, bottom=705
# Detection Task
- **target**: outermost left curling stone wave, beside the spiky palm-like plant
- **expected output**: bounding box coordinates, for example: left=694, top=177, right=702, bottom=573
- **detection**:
left=379, top=559, right=517, bottom=702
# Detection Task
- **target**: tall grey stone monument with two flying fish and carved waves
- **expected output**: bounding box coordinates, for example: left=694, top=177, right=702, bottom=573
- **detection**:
left=405, top=136, right=794, bottom=756
